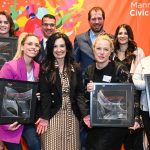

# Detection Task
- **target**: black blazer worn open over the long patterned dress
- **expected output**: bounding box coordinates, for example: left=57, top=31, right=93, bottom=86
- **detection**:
left=39, top=65, right=84, bottom=119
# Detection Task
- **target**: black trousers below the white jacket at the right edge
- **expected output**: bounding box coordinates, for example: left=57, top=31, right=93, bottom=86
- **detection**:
left=141, top=111, right=150, bottom=143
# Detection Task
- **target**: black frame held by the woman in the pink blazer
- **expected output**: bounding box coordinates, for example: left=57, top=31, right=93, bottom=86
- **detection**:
left=0, top=78, right=38, bottom=124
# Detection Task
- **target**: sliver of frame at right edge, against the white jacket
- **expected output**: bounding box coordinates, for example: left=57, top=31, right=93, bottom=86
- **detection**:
left=144, top=74, right=150, bottom=116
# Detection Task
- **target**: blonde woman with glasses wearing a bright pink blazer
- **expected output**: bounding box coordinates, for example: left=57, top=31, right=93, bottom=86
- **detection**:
left=0, top=33, right=40, bottom=150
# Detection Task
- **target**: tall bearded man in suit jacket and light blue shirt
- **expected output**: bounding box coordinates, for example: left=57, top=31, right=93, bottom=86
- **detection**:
left=74, top=7, right=109, bottom=72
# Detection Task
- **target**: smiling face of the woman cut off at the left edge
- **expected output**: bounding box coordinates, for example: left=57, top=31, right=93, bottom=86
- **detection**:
left=0, top=14, right=10, bottom=37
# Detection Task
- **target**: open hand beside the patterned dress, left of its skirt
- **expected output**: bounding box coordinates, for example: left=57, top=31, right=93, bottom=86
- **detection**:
left=35, top=118, right=48, bottom=134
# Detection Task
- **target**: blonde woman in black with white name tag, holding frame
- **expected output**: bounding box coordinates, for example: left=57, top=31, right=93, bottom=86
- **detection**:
left=78, top=35, right=139, bottom=150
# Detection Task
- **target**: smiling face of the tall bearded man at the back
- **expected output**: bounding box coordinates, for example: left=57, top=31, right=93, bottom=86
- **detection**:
left=89, top=10, right=104, bottom=33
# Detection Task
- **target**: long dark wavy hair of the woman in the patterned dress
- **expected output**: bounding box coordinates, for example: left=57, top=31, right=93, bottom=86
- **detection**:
left=41, top=32, right=77, bottom=83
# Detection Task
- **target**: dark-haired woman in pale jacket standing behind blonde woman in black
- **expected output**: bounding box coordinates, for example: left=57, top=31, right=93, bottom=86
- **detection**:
left=113, top=24, right=145, bottom=74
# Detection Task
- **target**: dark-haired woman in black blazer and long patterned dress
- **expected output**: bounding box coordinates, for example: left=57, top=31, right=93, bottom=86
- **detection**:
left=36, top=32, right=84, bottom=150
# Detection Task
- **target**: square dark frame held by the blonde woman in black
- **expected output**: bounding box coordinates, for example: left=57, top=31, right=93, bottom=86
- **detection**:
left=90, top=83, right=134, bottom=127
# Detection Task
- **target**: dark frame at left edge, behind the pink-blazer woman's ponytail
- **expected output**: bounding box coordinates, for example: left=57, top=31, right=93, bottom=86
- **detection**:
left=0, top=36, right=18, bottom=69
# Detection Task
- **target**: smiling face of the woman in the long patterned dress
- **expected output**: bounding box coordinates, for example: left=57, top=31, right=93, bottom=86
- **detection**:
left=53, top=38, right=67, bottom=60
